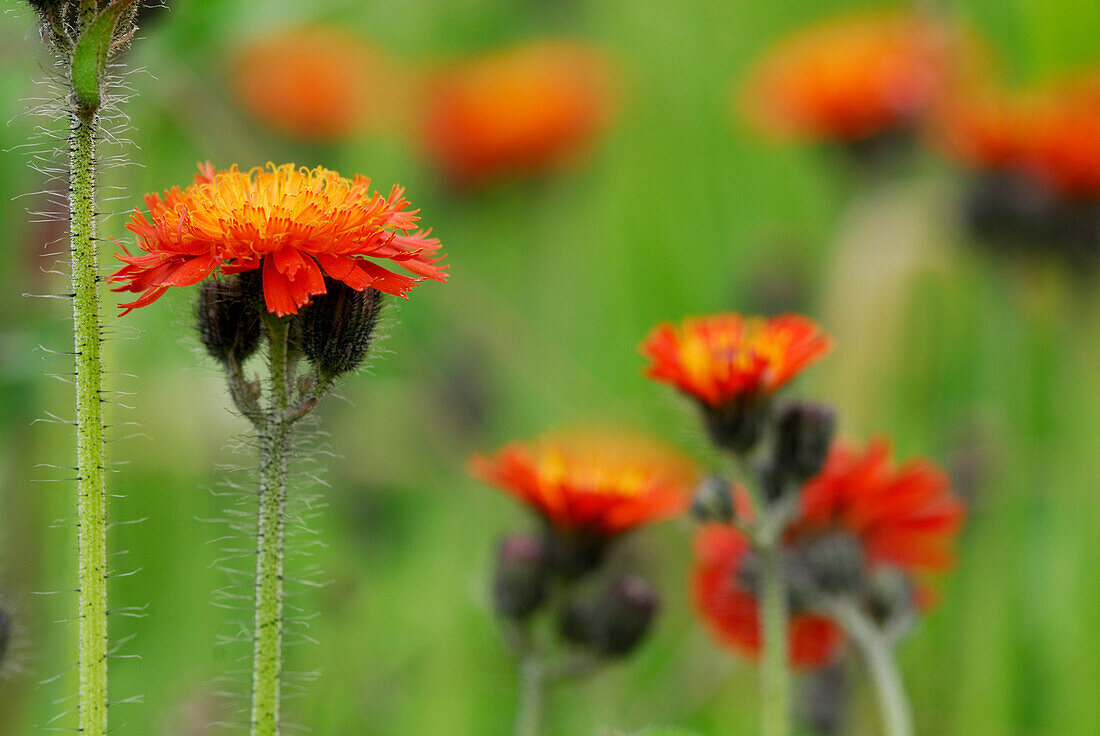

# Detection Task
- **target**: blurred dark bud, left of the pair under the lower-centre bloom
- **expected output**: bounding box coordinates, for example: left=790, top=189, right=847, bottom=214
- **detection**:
left=493, top=534, right=549, bottom=620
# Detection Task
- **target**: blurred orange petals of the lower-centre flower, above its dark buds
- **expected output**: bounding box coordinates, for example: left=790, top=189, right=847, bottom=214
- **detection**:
left=470, top=432, right=697, bottom=537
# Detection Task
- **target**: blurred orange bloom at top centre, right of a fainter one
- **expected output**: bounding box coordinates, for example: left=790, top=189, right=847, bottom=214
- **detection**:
left=424, top=42, right=612, bottom=186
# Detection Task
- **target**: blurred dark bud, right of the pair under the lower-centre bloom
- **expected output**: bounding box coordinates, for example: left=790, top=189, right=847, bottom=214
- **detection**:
left=560, top=574, right=661, bottom=657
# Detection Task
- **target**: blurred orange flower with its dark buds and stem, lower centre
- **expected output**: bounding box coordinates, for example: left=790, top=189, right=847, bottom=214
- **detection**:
left=470, top=430, right=699, bottom=721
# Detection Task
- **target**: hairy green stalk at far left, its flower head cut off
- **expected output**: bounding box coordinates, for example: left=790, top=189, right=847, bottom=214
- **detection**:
left=69, top=104, right=107, bottom=736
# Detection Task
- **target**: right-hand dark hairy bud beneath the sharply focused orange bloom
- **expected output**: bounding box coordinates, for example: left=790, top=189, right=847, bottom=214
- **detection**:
left=299, top=279, right=382, bottom=377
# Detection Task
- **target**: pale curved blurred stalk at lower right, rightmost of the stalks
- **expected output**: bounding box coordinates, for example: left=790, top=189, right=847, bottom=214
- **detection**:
left=828, top=601, right=913, bottom=736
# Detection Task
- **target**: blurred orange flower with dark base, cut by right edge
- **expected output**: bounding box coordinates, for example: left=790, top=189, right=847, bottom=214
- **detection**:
left=939, top=70, right=1100, bottom=266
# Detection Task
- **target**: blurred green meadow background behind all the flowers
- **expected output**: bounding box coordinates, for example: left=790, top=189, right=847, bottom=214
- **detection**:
left=0, top=0, right=1100, bottom=736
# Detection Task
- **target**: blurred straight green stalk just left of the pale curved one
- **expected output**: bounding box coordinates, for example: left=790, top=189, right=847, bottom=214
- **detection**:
left=757, top=542, right=791, bottom=736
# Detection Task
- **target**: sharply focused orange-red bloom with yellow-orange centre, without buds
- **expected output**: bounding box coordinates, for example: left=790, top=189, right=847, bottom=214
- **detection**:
left=108, top=164, right=447, bottom=317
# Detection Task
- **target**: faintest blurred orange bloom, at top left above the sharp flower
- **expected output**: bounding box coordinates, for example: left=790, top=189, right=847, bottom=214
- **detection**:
left=230, top=28, right=393, bottom=141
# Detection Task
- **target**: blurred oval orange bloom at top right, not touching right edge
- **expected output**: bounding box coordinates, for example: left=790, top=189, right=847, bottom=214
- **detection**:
left=745, top=12, right=949, bottom=141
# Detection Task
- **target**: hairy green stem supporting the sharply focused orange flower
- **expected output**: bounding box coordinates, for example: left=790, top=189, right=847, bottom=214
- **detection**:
left=252, top=315, right=292, bottom=736
